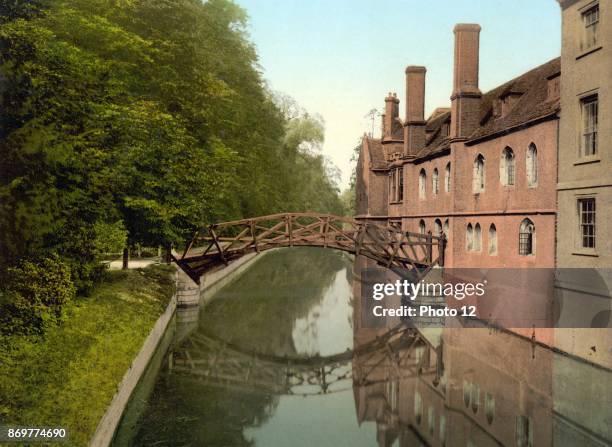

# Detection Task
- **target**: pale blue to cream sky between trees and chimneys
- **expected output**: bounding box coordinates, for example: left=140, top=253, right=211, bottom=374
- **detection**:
left=236, top=0, right=561, bottom=188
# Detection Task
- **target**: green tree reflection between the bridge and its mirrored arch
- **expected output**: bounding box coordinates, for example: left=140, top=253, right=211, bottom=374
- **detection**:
left=200, top=247, right=348, bottom=355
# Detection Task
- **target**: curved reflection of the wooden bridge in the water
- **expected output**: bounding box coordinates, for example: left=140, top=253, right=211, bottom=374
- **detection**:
left=171, top=325, right=438, bottom=395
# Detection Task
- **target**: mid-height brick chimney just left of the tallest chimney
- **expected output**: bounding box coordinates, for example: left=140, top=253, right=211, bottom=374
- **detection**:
left=404, top=66, right=427, bottom=156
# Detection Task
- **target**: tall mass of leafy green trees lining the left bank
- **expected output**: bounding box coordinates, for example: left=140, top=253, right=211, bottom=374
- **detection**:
left=0, top=0, right=342, bottom=291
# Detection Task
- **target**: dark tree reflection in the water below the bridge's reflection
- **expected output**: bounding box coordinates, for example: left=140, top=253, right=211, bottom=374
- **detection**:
left=135, top=376, right=278, bottom=447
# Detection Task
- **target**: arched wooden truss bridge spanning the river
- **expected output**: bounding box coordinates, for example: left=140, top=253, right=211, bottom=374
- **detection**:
left=175, top=213, right=445, bottom=282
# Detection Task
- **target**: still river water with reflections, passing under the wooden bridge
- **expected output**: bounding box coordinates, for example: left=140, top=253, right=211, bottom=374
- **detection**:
left=116, top=248, right=612, bottom=447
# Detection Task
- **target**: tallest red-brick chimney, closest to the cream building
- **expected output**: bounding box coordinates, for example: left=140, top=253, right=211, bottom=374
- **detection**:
left=450, top=23, right=482, bottom=138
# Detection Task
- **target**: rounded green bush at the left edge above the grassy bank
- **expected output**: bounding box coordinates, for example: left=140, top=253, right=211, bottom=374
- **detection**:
left=0, top=257, right=75, bottom=334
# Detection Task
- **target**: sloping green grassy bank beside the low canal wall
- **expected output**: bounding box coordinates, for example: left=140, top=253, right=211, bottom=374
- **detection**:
left=0, top=266, right=174, bottom=446
